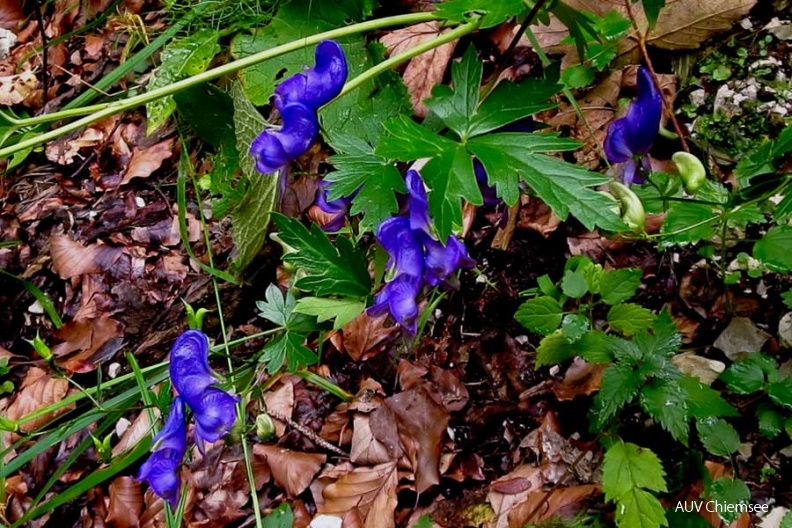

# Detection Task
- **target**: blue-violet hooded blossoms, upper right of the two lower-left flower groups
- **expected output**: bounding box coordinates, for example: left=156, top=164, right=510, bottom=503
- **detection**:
left=170, top=330, right=239, bottom=453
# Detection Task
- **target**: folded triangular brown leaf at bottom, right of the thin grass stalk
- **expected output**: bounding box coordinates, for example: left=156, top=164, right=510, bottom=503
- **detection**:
left=253, top=444, right=327, bottom=499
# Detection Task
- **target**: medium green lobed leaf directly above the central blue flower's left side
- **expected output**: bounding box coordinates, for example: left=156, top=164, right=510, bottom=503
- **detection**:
left=324, top=136, right=405, bottom=231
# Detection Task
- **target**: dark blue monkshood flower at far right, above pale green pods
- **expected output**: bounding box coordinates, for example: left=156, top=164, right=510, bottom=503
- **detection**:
left=604, top=66, right=663, bottom=185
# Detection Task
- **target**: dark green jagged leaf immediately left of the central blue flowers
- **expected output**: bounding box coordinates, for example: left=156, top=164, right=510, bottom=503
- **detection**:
left=275, top=213, right=371, bottom=297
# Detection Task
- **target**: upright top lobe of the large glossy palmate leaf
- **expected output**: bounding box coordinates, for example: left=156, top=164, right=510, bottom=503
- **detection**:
left=425, top=45, right=482, bottom=140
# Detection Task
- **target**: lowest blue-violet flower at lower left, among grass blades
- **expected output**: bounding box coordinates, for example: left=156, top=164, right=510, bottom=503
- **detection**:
left=137, top=398, right=187, bottom=508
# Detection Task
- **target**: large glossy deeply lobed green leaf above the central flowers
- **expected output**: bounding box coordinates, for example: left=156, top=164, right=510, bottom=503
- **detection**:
left=375, top=48, right=624, bottom=239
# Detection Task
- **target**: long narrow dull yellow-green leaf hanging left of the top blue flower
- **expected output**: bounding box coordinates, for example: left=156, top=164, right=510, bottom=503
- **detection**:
left=231, top=83, right=278, bottom=273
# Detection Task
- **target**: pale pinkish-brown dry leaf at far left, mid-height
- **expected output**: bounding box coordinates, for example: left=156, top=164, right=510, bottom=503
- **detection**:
left=49, top=235, right=122, bottom=279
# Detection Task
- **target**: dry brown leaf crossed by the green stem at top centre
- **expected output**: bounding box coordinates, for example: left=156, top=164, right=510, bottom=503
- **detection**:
left=380, top=21, right=457, bottom=117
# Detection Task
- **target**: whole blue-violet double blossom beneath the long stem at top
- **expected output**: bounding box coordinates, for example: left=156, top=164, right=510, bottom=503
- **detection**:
left=250, top=40, right=348, bottom=174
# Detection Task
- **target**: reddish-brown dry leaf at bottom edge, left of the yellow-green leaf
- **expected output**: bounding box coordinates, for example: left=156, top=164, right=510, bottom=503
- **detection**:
left=508, top=484, right=600, bottom=528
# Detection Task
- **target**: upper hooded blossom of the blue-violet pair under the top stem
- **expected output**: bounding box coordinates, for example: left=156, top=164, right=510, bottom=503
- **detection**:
left=274, top=40, right=348, bottom=112
